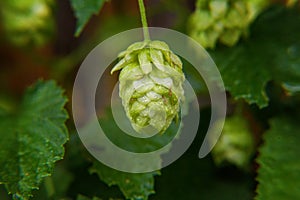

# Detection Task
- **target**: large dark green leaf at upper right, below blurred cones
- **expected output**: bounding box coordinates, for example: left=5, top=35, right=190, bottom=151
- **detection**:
left=212, top=7, right=300, bottom=107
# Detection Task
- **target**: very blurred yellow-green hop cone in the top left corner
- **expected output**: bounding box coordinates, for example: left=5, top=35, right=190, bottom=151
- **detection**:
left=0, top=0, right=55, bottom=47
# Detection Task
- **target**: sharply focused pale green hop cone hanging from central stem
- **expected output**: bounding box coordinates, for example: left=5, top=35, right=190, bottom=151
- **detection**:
left=111, top=41, right=185, bottom=133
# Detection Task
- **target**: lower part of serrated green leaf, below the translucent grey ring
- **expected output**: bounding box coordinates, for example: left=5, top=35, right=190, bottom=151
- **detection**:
left=90, top=161, right=159, bottom=200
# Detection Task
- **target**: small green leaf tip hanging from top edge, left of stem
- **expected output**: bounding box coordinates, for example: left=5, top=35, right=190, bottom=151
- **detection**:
left=71, top=0, right=106, bottom=36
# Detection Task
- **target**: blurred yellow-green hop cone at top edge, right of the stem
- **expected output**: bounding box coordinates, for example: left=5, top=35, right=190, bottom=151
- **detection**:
left=188, top=0, right=270, bottom=48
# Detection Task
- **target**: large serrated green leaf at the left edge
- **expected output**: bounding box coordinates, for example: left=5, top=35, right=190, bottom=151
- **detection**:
left=0, top=81, right=68, bottom=199
